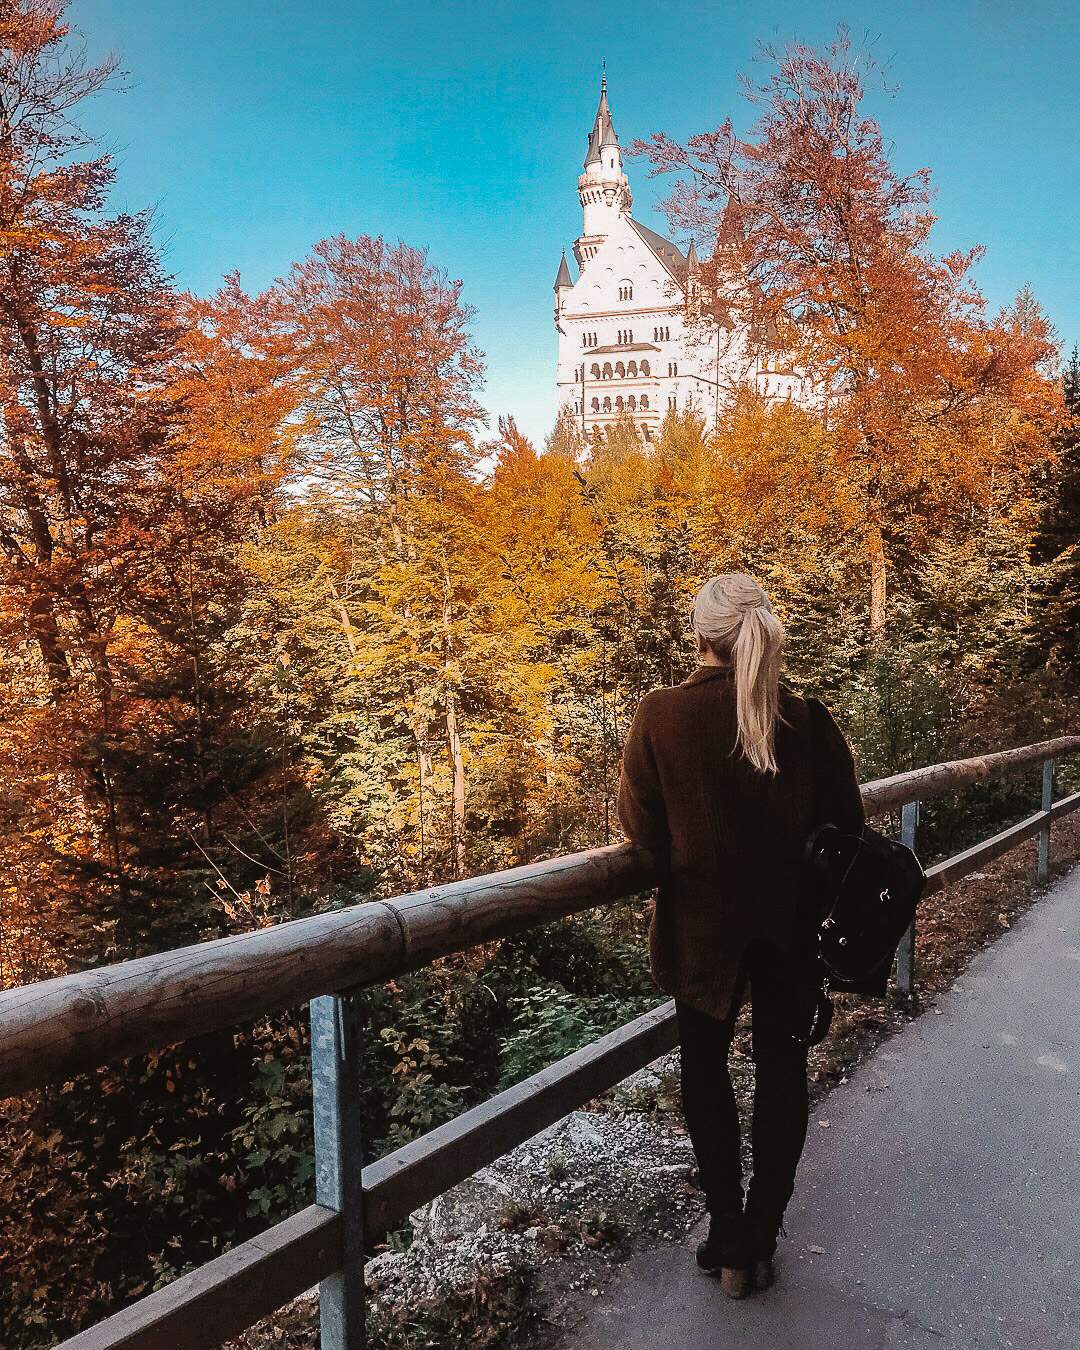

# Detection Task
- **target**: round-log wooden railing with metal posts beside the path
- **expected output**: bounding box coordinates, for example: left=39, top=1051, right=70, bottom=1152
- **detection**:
left=0, top=736, right=1080, bottom=1350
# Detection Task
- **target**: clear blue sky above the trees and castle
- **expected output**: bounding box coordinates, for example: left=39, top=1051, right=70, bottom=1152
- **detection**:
left=80, top=0, right=1080, bottom=437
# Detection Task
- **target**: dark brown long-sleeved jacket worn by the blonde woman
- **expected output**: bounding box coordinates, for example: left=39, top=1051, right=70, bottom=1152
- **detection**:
left=618, top=666, right=865, bottom=1021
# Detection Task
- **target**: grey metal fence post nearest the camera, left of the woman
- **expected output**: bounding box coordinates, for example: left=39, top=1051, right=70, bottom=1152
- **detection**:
left=311, top=994, right=365, bottom=1350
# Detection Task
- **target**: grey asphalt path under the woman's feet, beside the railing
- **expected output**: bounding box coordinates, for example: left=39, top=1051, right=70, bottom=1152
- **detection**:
left=572, top=868, right=1080, bottom=1350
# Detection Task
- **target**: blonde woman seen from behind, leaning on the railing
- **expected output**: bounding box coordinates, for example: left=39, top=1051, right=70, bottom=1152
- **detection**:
left=618, top=572, right=864, bottom=1297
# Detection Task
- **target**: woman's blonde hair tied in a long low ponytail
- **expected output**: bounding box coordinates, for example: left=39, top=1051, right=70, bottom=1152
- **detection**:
left=690, top=572, right=784, bottom=774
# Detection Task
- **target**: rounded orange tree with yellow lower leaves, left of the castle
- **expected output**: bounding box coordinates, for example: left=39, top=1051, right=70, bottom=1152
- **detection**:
left=244, top=236, right=482, bottom=872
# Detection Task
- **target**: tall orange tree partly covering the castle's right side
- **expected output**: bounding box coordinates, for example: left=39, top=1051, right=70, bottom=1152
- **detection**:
left=635, top=31, right=1054, bottom=635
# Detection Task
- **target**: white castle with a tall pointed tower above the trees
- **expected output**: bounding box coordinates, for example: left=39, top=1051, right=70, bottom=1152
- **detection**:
left=555, top=76, right=806, bottom=440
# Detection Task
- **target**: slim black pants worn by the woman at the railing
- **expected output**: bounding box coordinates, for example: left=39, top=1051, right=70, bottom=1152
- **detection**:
left=675, top=940, right=809, bottom=1231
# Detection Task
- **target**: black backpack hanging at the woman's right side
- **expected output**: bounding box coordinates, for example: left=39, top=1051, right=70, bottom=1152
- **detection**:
left=806, top=825, right=926, bottom=1045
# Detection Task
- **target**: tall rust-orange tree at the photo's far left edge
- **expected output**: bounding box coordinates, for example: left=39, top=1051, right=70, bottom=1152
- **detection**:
left=0, top=0, right=173, bottom=972
